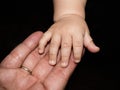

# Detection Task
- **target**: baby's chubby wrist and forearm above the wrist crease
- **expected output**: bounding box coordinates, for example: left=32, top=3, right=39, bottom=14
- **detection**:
left=53, top=0, right=86, bottom=22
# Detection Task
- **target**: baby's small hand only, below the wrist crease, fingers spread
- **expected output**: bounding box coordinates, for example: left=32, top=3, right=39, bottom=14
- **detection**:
left=39, top=15, right=99, bottom=67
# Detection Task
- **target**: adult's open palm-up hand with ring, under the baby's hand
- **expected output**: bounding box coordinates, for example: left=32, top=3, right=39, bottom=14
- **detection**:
left=0, top=31, right=76, bottom=90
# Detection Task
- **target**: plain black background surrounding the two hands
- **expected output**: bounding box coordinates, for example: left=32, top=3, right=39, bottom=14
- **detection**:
left=0, top=0, right=120, bottom=90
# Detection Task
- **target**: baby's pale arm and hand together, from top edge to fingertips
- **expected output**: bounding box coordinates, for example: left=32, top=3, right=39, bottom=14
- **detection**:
left=39, top=0, right=100, bottom=67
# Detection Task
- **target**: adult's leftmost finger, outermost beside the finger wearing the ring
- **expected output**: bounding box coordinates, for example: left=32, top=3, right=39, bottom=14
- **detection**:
left=1, top=31, right=42, bottom=68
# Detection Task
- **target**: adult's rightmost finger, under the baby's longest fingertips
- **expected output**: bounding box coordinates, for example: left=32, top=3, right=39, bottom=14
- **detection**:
left=44, top=52, right=77, bottom=90
